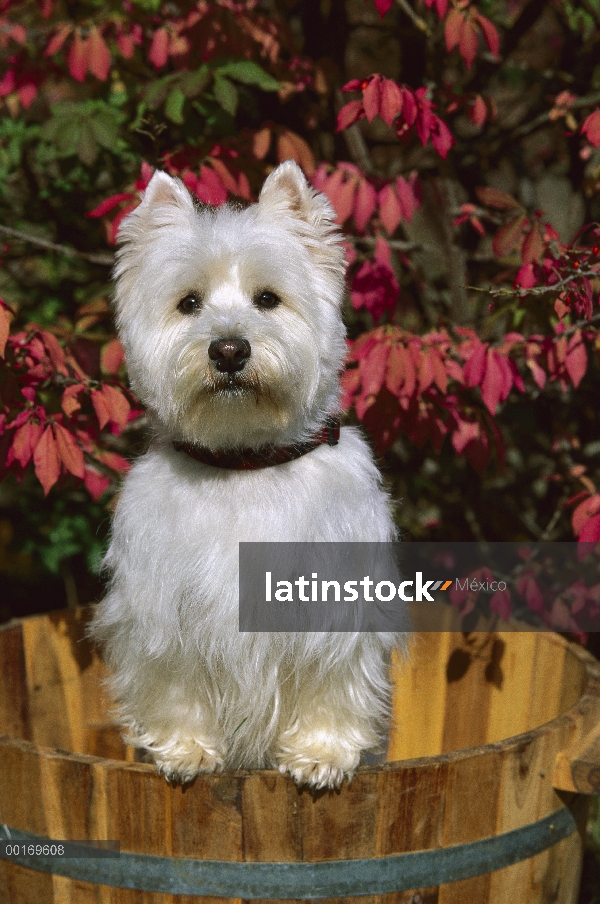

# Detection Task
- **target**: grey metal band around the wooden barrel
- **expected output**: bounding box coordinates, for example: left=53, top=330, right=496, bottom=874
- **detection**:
left=0, top=807, right=577, bottom=900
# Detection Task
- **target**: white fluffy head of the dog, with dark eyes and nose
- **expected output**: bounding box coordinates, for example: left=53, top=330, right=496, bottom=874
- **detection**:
left=115, top=160, right=345, bottom=449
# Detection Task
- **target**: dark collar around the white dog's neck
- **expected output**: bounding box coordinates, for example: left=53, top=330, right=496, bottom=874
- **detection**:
left=173, top=417, right=340, bottom=471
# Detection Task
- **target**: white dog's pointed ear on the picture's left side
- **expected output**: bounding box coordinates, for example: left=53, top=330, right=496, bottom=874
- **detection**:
left=117, top=170, right=195, bottom=243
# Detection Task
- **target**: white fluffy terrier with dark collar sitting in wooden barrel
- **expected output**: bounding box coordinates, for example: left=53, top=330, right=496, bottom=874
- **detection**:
left=91, top=161, right=401, bottom=788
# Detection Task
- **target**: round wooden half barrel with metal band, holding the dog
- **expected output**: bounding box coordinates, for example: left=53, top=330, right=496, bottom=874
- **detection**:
left=0, top=610, right=600, bottom=904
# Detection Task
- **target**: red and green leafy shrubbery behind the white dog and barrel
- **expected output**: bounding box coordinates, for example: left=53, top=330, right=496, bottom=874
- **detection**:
left=0, top=0, right=600, bottom=901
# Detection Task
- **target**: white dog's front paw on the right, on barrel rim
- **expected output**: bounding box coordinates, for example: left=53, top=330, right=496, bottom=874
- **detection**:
left=275, top=735, right=360, bottom=790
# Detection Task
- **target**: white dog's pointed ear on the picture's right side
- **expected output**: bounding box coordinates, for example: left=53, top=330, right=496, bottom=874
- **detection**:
left=258, top=160, right=344, bottom=270
